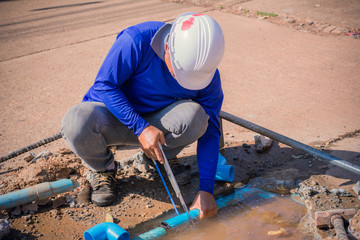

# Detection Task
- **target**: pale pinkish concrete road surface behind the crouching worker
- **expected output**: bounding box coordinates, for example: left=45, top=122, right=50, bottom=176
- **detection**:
left=0, top=0, right=360, bottom=159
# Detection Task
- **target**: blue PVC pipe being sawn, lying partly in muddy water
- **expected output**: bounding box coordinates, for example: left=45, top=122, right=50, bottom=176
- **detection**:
left=133, top=187, right=275, bottom=240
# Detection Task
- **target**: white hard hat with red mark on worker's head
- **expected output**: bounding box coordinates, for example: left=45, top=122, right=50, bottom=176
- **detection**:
left=151, top=13, right=225, bottom=90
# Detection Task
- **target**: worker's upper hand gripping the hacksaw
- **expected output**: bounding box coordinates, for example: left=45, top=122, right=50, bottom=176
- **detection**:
left=138, top=125, right=165, bottom=164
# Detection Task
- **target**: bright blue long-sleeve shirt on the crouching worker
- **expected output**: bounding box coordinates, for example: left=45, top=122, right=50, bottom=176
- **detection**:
left=83, top=22, right=223, bottom=193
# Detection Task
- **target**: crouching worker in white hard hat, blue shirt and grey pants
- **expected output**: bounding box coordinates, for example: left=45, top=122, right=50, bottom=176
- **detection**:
left=62, top=13, right=224, bottom=218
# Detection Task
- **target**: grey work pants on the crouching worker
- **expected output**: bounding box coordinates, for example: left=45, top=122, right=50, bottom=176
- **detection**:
left=61, top=100, right=209, bottom=171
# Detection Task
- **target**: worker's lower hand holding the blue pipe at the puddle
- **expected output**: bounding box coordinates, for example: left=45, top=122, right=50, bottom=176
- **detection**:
left=190, top=191, right=218, bottom=219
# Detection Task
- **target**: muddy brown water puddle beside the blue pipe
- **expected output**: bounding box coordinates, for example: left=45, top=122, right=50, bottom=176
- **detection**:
left=162, top=196, right=312, bottom=240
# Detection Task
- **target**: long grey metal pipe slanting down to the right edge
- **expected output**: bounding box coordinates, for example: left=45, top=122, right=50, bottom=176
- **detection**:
left=220, top=111, right=360, bottom=175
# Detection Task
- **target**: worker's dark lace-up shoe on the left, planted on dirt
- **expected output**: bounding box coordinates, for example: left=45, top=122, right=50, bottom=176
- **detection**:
left=90, top=168, right=116, bottom=207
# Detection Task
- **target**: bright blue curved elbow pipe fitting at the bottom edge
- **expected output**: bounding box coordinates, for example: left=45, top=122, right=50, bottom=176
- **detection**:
left=84, top=222, right=130, bottom=240
